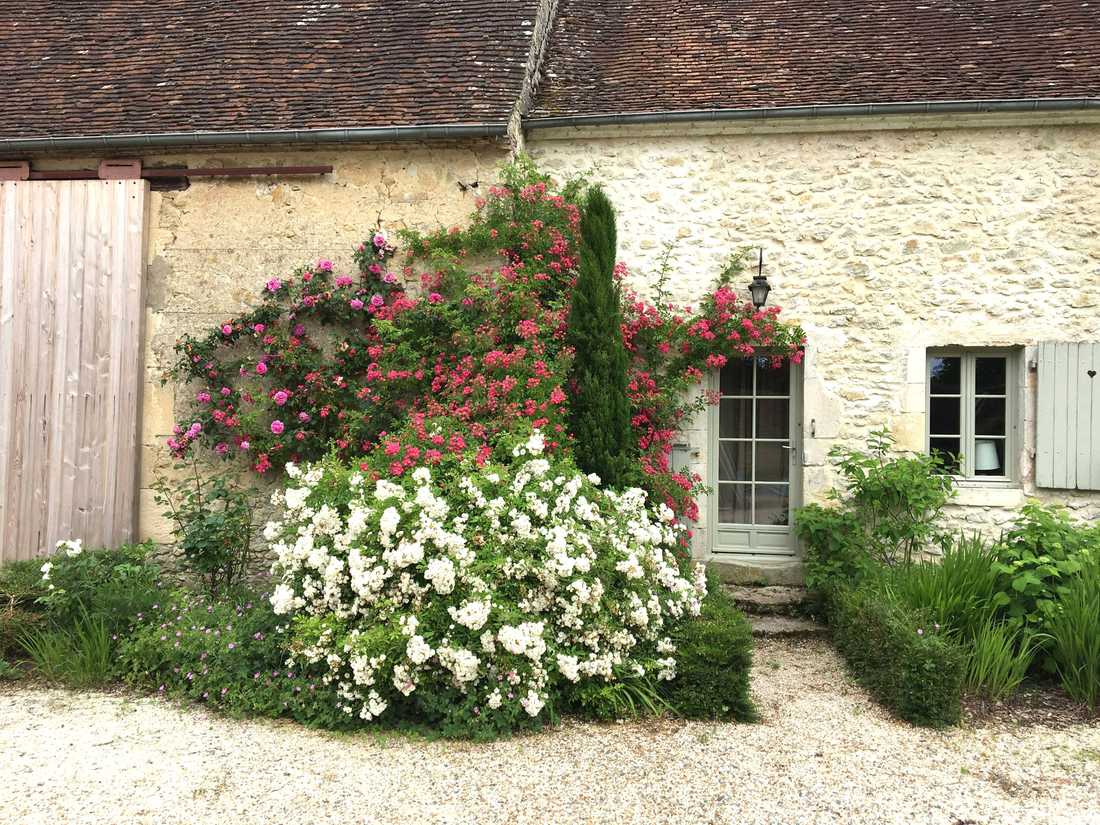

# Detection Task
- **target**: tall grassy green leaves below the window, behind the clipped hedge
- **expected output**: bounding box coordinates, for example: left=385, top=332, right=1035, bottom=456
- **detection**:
left=891, top=534, right=997, bottom=642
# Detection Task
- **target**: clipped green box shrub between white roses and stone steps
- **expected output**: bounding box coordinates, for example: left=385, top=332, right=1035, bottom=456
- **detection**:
left=661, top=576, right=757, bottom=722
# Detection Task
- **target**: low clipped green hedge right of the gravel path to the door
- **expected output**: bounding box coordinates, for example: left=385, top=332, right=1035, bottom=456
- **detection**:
left=828, top=579, right=964, bottom=727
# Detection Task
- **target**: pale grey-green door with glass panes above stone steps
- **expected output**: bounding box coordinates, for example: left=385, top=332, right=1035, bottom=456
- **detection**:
left=711, top=359, right=801, bottom=556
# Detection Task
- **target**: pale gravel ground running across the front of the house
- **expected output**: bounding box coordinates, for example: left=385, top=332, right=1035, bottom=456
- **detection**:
left=0, top=640, right=1100, bottom=825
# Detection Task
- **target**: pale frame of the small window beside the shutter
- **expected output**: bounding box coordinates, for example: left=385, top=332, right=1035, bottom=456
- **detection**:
left=924, top=347, right=1024, bottom=486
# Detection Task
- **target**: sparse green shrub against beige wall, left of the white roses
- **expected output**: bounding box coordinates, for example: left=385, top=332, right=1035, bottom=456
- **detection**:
left=152, top=455, right=254, bottom=593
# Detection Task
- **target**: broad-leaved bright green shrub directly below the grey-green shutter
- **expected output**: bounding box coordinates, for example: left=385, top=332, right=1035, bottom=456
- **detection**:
left=993, top=502, right=1100, bottom=631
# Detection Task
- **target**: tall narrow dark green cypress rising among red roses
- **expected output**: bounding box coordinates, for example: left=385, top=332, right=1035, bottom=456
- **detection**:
left=569, top=187, right=637, bottom=487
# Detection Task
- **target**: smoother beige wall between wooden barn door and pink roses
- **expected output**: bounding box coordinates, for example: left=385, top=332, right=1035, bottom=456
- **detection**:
left=35, top=142, right=507, bottom=541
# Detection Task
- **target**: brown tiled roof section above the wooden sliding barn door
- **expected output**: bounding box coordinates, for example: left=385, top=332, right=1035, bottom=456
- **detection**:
left=0, top=0, right=537, bottom=139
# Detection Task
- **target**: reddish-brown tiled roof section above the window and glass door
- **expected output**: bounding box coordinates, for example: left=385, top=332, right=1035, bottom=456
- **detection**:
left=531, top=0, right=1100, bottom=118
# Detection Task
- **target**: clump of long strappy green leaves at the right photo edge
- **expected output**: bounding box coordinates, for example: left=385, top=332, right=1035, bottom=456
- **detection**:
left=1047, top=559, right=1100, bottom=708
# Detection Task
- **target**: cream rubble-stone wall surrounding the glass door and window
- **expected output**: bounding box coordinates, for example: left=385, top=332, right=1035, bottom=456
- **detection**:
left=529, top=121, right=1100, bottom=554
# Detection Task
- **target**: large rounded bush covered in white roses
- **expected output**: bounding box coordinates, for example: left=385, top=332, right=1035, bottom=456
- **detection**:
left=265, top=431, right=706, bottom=735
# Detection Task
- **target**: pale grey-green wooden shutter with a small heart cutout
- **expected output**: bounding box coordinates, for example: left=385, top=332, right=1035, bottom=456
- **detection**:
left=1035, top=341, right=1100, bottom=490
